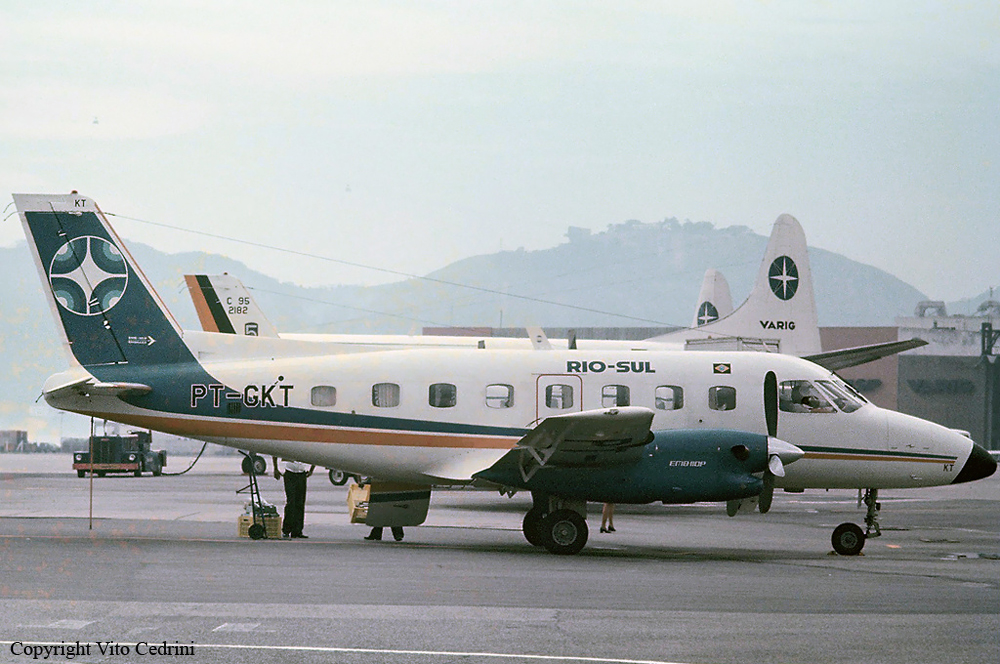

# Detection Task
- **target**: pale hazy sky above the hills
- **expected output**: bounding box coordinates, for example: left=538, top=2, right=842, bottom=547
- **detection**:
left=0, top=0, right=1000, bottom=300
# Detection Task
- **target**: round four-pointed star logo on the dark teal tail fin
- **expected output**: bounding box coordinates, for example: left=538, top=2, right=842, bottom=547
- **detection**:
left=49, top=235, right=128, bottom=316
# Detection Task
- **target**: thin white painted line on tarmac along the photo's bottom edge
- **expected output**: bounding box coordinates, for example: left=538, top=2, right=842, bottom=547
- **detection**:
left=0, top=641, right=686, bottom=664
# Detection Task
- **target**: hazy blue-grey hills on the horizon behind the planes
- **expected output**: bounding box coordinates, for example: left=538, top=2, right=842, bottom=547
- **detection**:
left=0, top=219, right=926, bottom=441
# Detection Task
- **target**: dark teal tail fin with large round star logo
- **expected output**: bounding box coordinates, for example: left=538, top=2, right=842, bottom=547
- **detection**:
left=14, top=192, right=195, bottom=369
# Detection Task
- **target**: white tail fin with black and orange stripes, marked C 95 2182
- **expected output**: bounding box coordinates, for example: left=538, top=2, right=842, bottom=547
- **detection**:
left=184, top=274, right=278, bottom=338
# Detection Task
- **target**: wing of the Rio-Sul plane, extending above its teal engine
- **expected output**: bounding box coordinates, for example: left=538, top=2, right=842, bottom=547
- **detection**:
left=478, top=406, right=653, bottom=482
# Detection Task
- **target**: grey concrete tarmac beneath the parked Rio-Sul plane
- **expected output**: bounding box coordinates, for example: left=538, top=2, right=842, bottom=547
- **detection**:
left=0, top=455, right=1000, bottom=664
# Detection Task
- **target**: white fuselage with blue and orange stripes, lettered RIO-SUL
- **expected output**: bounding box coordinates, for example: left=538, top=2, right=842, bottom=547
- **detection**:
left=49, top=342, right=972, bottom=489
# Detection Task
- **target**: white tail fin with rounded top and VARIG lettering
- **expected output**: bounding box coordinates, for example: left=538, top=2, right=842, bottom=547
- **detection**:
left=650, top=214, right=822, bottom=355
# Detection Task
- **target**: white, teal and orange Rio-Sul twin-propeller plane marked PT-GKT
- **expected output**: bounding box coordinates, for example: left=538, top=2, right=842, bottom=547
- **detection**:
left=14, top=193, right=996, bottom=553
